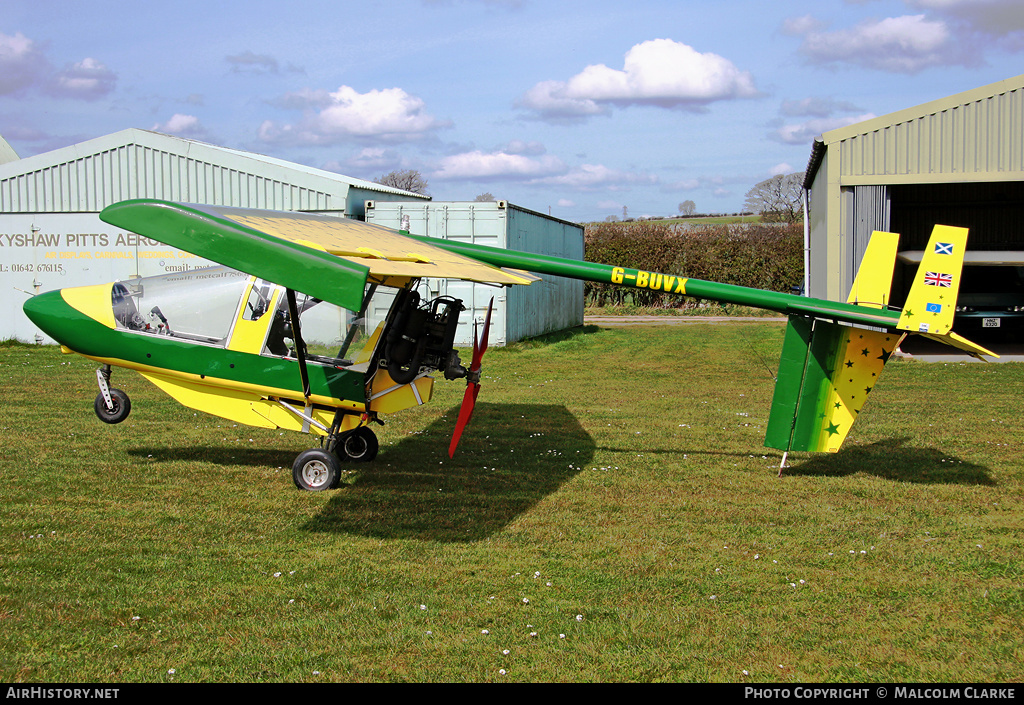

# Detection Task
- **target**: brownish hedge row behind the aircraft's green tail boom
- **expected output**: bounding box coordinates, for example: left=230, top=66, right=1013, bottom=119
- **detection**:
left=585, top=221, right=804, bottom=308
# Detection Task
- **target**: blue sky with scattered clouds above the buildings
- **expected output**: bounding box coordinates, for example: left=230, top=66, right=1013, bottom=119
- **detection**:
left=0, top=0, right=1024, bottom=220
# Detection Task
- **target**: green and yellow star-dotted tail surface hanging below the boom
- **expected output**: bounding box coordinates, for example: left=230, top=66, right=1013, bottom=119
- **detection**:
left=765, top=317, right=903, bottom=453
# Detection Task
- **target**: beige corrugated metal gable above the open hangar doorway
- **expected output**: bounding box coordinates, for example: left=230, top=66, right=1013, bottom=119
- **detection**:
left=806, top=75, right=1024, bottom=185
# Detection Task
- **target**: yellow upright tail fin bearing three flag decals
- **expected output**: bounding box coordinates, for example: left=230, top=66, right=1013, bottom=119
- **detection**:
left=896, top=225, right=967, bottom=336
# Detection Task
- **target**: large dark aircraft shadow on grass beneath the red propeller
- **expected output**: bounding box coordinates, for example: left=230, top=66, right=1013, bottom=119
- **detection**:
left=303, top=403, right=595, bottom=542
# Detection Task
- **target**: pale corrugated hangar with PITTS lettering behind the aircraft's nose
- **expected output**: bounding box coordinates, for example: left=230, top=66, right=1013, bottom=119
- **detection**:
left=0, top=129, right=430, bottom=342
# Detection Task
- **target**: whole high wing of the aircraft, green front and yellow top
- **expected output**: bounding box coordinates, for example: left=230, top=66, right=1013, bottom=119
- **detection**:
left=99, top=199, right=538, bottom=310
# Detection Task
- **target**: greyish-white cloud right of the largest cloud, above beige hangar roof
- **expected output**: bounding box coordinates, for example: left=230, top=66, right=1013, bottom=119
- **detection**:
left=787, top=14, right=976, bottom=74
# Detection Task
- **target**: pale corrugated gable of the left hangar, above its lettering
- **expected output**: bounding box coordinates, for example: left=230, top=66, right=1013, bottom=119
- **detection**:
left=0, top=129, right=428, bottom=213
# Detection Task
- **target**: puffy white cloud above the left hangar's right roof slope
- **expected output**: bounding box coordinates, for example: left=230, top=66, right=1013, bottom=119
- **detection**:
left=259, top=86, right=451, bottom=144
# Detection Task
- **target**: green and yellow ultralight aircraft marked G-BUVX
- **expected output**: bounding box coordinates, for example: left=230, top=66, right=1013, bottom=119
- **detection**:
left=25, top=200, right=994, bottom=491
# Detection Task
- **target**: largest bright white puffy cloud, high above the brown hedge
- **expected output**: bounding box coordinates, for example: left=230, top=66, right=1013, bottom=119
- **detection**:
left=517, top=39, right=760, bottom=121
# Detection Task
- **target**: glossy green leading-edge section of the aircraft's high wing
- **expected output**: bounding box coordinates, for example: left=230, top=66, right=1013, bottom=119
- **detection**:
left=99, top=200, right=369, bottom=310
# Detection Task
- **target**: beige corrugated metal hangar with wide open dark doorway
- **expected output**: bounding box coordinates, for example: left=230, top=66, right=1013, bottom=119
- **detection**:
left=804, top=75, right=1024, bottom=341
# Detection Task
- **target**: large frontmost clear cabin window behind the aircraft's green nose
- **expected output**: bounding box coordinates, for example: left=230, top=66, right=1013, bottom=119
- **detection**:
left=111, top=266, right=252, bottom=345
